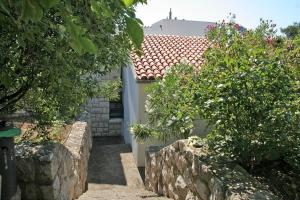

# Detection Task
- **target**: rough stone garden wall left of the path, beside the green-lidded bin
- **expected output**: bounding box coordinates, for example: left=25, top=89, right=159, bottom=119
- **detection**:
left=16, top=118, right=92, bottom=200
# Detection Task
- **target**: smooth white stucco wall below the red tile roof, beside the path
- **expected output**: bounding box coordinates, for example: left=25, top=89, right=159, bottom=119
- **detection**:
left=123, top=64, right=207, bottom=167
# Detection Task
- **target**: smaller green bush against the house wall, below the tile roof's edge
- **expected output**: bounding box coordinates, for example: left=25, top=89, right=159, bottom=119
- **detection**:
left=132, top=64, right=199, bottom=141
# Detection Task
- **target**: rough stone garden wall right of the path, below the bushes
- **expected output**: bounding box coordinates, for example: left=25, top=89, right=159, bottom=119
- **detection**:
left=145, top=140, right=278, bottom=200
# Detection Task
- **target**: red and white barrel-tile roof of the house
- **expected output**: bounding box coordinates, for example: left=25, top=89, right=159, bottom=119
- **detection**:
left=131, top=35, right=208, bottom=80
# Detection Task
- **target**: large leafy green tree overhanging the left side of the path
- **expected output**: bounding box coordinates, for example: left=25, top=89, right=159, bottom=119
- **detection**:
left=0, top=0, right=146, bottom=123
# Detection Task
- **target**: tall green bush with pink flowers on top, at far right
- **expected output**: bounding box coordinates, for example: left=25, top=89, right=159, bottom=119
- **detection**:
left=199, top=21, right=300, bottom=166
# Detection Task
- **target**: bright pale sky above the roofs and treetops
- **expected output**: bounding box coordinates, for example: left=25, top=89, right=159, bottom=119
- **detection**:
left=136, top=0, right=300, bottom=28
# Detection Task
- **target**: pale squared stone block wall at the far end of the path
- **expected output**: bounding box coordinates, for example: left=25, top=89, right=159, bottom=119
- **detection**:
left=85, top=70, right=122, bottom=136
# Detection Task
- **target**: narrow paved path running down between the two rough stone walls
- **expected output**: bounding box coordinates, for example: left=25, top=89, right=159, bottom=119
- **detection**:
left=79, top=137, right=170, bottom=200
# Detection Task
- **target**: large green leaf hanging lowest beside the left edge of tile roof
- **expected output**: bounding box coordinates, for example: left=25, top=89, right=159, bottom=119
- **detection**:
left=126, top=18, right=144, bottom=49
